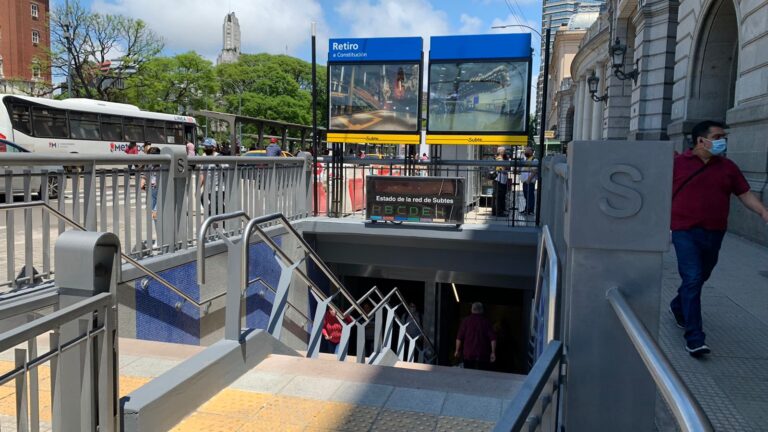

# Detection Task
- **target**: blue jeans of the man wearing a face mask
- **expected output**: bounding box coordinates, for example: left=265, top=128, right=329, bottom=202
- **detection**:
left=669, top=228, right=725, bottom=348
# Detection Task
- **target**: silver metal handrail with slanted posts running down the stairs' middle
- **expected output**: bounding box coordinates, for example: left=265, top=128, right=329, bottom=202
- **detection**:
left=197, top=211, right=436, bottom=363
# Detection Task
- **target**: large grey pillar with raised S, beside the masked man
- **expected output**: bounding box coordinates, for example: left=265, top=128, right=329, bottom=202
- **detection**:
left=561, top=141, right=682, bottom=431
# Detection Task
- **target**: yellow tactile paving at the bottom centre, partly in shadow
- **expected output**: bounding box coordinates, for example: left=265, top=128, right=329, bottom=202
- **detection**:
left=172, top=389, right=494, bottom=432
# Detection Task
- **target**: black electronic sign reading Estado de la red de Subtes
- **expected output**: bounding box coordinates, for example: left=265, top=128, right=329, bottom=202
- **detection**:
left=366, top=176, right=464, bottom=224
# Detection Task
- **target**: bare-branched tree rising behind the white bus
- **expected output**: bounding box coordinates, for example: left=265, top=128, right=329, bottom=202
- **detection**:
left=50, top=0, right=163, bottom=101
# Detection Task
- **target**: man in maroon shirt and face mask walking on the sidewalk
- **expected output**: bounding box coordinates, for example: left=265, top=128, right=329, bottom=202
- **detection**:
left=669, top=121, right=768, bottom=357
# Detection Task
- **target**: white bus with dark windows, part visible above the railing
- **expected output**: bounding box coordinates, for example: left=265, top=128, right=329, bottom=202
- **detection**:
left=0, top=95, right=197, bottom=153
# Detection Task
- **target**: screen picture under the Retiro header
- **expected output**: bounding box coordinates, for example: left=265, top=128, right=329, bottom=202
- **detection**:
left=329, top=63, right=420, bottom=132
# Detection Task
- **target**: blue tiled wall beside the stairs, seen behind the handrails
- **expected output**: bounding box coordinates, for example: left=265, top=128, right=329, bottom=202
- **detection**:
left=134, top=237, right=282, bottom=345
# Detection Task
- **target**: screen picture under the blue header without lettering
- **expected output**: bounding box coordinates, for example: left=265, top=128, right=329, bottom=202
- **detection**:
left=428, top=61, right=528, bottom=133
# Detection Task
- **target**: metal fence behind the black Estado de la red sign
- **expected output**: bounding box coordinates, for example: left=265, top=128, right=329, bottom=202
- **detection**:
left=317, top=158, right=538, bottom=226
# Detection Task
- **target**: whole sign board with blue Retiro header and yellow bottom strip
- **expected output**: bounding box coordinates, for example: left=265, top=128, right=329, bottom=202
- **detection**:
left=328, top=37, right=423, bottom=144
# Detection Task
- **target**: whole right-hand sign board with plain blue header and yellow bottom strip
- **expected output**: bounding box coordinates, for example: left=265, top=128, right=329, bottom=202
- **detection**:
left=427, top=34, right=531, bottom=145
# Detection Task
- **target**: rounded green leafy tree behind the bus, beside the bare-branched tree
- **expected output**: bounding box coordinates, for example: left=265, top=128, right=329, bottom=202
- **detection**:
left=123, top=52, right=219, bottom=114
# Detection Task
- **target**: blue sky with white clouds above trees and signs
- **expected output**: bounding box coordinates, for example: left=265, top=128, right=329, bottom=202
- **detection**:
left=51, top=0, right=541, bottom=96
